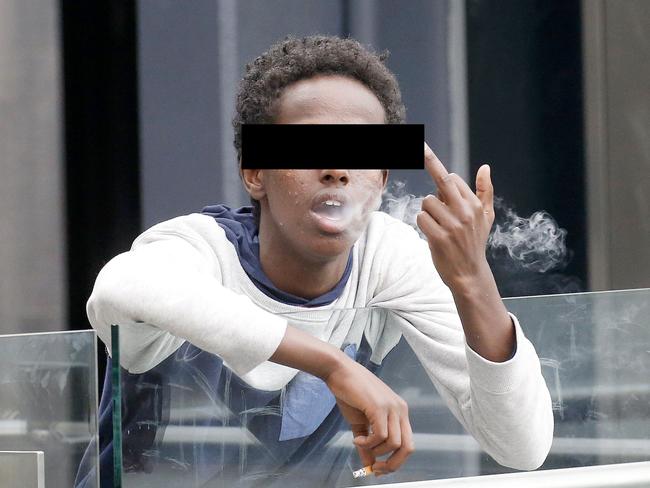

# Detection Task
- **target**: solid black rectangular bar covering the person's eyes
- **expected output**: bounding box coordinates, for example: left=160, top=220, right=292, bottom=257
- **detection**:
left=241, top=124, right=424, bottom=169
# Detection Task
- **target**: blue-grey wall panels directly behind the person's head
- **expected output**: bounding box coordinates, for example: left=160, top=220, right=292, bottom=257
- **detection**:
left=138, top=0, right=464, bottom=227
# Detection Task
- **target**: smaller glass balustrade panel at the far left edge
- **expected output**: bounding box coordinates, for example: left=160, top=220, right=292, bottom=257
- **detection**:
left=0, top=330, right=99, bottom=488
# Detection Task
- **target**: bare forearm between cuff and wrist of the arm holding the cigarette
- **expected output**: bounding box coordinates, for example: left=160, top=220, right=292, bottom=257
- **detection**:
left=269, top=324, right=350, bottom=380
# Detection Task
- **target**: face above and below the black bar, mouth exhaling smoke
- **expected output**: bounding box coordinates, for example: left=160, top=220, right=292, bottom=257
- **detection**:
left=248, top=75, right=388, bottom=258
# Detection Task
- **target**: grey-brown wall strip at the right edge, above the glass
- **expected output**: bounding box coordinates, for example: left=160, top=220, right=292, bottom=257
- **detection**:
left=583, top=0, right=650, bottom=290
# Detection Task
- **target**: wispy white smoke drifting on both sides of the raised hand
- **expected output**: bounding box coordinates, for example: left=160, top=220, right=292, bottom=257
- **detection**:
left=380, top=181, right=568, bottom=273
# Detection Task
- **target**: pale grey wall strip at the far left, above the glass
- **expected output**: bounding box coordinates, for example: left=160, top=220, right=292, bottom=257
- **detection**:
left=0, top=0, right=67, bottom=334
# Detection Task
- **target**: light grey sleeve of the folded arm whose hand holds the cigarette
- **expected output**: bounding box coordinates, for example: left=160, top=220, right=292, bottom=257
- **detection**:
left=86, top=216, right=287, bottom=376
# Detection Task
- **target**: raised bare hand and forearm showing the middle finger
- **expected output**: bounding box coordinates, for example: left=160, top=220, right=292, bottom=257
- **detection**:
left=416, top=142, right=516, bottom=362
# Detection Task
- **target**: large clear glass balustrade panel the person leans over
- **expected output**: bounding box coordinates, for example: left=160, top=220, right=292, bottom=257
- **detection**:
left=102, top=290, right=650, bottom=488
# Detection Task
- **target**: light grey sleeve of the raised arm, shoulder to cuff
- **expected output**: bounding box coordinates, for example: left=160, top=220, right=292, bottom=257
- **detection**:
left=371, top=217, right=553, bottom=470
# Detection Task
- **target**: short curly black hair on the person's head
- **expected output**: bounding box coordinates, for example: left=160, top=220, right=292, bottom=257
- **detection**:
left=232, top=34, right=406, bottom=226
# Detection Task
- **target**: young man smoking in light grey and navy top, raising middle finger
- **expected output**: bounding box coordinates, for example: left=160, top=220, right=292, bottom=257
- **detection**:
left=80, top=35, right=553, bottom=486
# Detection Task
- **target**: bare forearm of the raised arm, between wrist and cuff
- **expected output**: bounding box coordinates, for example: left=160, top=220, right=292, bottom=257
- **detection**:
left=451, top=262, right=516, bottom=362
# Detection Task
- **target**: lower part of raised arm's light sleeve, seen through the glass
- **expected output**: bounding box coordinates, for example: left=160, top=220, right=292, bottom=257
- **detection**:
left=394, top=309, right=553, bottom=469
